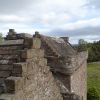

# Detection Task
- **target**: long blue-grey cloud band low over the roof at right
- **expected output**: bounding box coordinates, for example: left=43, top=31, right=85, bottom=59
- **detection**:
left=48, top=26, right=100, bottom=37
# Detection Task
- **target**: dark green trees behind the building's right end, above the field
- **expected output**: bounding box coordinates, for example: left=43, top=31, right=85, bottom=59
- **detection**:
left=75, top=39, right=100, bottom=62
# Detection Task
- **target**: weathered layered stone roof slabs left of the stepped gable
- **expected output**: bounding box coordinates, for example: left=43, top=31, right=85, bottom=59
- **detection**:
left=0, top=40, right=24, bottom=93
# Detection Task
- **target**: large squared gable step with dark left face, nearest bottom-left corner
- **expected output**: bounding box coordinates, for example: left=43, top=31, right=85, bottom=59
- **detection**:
left=4, top=76, right=24, bottom=94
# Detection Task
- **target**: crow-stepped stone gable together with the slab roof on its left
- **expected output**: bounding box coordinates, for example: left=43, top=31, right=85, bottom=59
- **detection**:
left=0, top=30, right=63, bottom=100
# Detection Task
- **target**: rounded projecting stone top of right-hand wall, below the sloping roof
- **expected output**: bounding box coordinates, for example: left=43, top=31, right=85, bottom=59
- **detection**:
left=51, top=51, right=88, bottom=75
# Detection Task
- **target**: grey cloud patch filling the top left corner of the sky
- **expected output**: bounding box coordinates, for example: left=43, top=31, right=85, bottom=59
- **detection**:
left=0, top=0, right=38, bottom=14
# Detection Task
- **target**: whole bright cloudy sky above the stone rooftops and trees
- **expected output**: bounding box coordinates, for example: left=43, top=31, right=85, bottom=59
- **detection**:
left=0, top=0, right=100, bottom=43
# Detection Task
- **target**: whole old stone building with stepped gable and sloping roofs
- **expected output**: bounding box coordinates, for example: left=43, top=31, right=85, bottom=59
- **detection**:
left=0, top=29, right=88, bottom=100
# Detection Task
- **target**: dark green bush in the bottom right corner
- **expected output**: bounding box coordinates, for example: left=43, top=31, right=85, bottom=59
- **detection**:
left=87, top=87, right=100, bottom=100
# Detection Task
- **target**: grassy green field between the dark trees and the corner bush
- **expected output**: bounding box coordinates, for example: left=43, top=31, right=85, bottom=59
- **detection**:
left=87, top=63, right=100, bottom=93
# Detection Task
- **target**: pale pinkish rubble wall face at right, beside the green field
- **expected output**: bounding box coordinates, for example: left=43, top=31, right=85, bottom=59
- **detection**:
left=71, top=52, right=87, bottom=100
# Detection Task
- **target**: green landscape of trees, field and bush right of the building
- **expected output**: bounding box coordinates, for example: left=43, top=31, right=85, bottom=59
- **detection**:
left=76, top=39, right=100, bottom=100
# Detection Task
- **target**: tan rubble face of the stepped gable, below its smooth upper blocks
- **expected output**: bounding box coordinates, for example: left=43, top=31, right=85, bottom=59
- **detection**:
left=0, top=50, right=62, bottom=100
